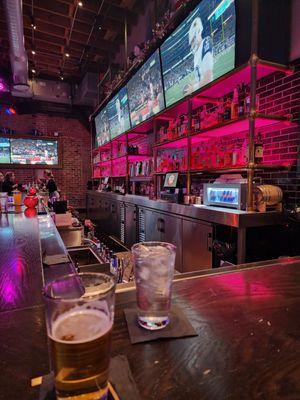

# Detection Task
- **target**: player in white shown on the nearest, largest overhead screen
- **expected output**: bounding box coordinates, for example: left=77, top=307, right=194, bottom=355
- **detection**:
left=189, top=17, right=214, bottom=91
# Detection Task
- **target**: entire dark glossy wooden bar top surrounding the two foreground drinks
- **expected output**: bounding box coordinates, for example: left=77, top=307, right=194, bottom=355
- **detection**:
left=0, top=214, right=300, bottom=400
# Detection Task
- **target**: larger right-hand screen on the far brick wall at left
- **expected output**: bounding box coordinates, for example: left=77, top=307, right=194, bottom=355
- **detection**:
left=10, top=139, right=59, bottom=165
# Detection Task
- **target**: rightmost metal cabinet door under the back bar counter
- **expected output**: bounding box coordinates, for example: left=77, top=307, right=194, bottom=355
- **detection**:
left=182, top=220, right=213, bottom=272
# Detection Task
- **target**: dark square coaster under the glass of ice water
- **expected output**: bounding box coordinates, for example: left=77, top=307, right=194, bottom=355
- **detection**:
left=124, top=306, right=198, bottom=344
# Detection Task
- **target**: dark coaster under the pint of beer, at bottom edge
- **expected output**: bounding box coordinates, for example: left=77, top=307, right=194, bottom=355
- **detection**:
left=34, top=356, right=140, bottom=400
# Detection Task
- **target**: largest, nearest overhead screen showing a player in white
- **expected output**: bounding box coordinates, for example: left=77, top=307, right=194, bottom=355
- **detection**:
left=160, top=0, right=236, bottom=107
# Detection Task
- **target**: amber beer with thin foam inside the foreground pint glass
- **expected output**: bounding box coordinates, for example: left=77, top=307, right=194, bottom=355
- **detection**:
left=50, top=309, right=112, bottom=400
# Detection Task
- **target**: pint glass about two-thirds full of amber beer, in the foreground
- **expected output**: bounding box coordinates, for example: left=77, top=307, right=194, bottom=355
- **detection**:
left=43, top=273, right=115, bottom=400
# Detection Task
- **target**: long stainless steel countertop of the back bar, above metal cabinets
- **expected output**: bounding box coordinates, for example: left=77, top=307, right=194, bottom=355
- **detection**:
left=88, top=191, right=284, bottom=228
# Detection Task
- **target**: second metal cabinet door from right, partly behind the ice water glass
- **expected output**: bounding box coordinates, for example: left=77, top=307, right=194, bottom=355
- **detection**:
left=158, top=214, right=182, bottom=272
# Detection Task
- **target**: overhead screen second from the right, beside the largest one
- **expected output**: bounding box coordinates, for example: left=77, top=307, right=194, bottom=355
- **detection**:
left=127, top=50, right=165, bottom=127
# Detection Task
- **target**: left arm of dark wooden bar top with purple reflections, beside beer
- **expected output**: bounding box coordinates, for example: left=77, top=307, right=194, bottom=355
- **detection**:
left=0, top=208, right=73, bottom=400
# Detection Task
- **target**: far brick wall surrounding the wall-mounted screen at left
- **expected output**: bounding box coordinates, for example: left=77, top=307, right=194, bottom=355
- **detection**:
left=0, top=112, right=91, bottom=207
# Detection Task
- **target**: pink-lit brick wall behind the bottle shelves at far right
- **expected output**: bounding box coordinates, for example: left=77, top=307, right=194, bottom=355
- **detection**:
left=258, top=64, right=300, bottom=207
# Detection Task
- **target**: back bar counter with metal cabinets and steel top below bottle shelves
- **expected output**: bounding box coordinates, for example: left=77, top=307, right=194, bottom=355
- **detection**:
left=87, top=191, right=287, bottom=272
